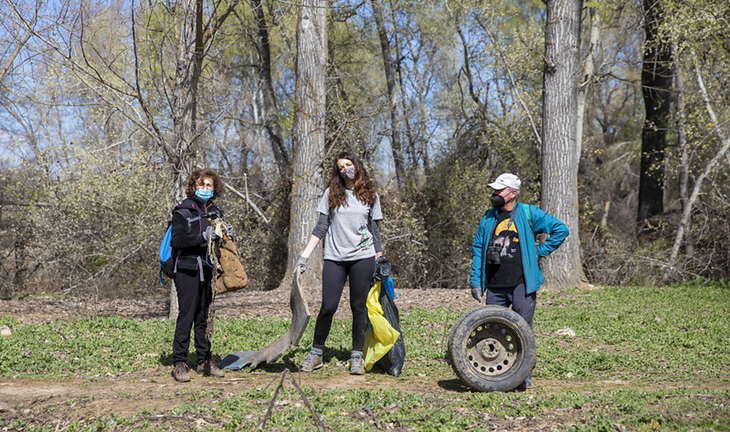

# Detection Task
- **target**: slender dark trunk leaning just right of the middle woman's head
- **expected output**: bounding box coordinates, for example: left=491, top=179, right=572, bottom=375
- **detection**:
left=371, top=0, right=406, bottom=190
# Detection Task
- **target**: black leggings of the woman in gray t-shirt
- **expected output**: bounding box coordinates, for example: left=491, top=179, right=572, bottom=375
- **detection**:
left=312, top=257, right=375, bottom=351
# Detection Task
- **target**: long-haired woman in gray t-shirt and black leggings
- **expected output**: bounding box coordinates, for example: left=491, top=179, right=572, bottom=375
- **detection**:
left=296, top=152, right=383, bottom=375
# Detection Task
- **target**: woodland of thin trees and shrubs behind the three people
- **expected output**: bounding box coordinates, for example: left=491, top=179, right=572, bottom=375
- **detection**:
left=0, top=0, right=730, bottom=298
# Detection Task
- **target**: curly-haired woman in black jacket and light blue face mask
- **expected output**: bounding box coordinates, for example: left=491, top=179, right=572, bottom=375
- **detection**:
left=171, top=168, right=230, bottom=382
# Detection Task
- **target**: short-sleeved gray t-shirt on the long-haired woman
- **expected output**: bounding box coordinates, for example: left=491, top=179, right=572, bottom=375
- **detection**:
left=317, top=188, right=383, bottom=261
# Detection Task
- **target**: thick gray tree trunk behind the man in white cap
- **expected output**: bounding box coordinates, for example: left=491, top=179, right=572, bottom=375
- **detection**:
left=542, top=0, right=583, bottom=288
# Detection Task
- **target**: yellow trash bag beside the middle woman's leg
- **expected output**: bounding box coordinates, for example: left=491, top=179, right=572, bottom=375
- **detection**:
left=363, top=281, right=400, bottom=372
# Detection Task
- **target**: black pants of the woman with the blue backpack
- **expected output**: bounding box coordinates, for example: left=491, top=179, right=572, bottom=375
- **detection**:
left=172, top=267, right=213, bottom=363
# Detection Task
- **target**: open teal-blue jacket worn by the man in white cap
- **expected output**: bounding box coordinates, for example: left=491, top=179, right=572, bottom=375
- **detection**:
left=470, top=203, right=569, bottom=294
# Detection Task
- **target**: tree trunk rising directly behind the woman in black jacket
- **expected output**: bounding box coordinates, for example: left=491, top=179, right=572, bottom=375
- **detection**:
left=168, top=0, right=203, bottom=319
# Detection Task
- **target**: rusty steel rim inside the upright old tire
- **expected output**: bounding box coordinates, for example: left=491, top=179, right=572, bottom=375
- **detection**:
left=466, top=322, right=522, bottom=377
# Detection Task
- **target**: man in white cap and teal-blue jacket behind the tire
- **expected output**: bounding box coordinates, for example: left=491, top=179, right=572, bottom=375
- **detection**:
left=470, top=173, right=568, bottom=389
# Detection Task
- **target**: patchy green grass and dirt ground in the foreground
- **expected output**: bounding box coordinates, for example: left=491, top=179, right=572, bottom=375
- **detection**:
left=0, top=281, right=730, bottom=431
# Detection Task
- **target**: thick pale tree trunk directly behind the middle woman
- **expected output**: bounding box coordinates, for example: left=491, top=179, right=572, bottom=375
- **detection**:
left=282, top=0, right=328, bottom=286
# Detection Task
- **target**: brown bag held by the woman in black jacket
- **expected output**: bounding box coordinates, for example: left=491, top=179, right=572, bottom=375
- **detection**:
left=212, top=219, right=248, bottom=294
